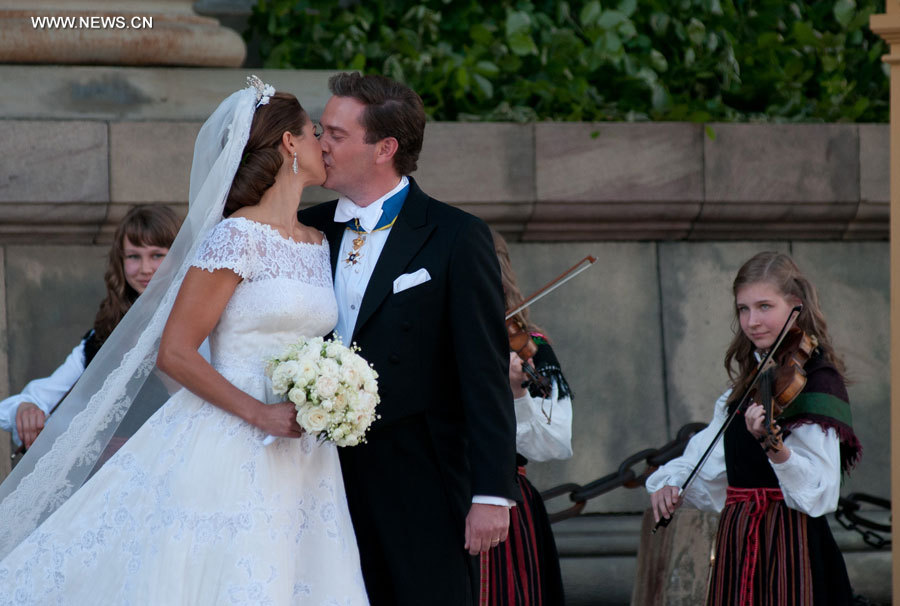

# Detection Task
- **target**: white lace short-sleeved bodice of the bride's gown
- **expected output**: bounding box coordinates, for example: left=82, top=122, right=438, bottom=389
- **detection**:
left=193, top=217, right=337, bottom=375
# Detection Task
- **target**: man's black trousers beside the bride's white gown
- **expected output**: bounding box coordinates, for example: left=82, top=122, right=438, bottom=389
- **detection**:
left=340, top=415, right=478, bottom=606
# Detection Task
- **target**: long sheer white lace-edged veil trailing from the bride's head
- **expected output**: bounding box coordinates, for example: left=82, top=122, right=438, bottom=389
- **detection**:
left=0, top=76, right=275, bottom=559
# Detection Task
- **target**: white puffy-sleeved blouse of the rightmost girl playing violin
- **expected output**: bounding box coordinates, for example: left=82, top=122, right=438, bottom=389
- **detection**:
left=646, top=389, right=841, bottom=517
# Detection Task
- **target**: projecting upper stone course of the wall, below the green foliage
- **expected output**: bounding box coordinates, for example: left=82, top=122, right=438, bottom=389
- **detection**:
left=0, top=65, right=888, bottom=243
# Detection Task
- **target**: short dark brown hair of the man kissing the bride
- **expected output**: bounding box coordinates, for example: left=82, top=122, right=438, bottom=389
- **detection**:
left=328, top=72, right=425, bottom=175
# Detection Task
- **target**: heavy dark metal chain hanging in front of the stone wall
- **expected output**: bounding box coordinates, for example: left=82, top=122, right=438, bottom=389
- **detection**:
left=541, top=423, right=891, bottom=549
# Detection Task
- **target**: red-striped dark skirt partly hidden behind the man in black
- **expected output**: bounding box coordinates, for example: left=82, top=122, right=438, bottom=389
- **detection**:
left=479, top=467, right=565, bottom=606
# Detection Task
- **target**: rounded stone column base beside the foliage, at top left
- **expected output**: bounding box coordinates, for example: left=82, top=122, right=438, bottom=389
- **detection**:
left=0, top=0, right=246, bottom=67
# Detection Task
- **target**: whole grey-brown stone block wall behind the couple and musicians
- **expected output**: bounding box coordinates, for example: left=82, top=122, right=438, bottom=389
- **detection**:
left=0, top=66, right=890, bottom=595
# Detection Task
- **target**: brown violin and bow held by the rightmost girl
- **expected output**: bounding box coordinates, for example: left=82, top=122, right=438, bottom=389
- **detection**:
left=652, top=305, right=818, bottom=534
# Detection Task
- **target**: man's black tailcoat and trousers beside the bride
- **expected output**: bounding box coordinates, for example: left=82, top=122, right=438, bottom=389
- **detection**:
left=299, top=179, right=519, bottom=606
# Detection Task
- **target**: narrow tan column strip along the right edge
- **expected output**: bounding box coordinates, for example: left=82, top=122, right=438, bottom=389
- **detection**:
left=869, top=0, right=900, bottom=605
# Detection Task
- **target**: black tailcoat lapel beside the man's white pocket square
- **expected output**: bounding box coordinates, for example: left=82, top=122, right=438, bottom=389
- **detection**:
left=354, top=183, right=435, bottom=342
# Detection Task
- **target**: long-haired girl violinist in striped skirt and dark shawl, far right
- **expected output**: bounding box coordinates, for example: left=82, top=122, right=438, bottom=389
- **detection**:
left=646, top=252, right=861, bottom=606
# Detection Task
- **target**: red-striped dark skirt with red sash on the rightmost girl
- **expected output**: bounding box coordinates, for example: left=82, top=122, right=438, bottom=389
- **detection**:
left=707, top=487, right=852, bottom=606
